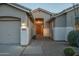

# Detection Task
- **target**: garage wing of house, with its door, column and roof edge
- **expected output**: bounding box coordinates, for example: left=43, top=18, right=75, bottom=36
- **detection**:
left=0, top=3, right=32, bottom=45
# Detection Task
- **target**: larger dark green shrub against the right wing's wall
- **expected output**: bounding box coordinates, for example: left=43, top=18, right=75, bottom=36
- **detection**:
left=68, top=31, right=79, bottom=46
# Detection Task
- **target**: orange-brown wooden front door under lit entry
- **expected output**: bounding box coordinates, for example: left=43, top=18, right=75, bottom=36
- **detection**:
left=35, top=18, right=43, bottom=39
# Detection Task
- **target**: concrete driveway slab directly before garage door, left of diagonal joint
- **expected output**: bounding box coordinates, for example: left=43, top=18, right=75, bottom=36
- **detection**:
left=0, top=45, right=24, bottom=56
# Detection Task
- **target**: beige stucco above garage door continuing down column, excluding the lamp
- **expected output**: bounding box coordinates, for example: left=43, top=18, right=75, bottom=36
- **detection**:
left=0, top=4, right=30, bottom=45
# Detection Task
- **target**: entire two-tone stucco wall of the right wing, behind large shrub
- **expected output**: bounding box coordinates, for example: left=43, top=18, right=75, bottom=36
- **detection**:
left=54, top=9, right=79, bottom=41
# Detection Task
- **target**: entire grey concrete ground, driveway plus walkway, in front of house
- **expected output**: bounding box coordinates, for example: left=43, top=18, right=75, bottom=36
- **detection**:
left=0, top=40, right=79, bottom=56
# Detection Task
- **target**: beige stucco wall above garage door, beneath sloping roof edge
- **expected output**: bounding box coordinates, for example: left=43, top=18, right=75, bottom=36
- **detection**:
left=0, top=4, right=27, bottom=20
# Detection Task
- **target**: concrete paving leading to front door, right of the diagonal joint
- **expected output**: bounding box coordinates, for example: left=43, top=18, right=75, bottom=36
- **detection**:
left=22, top=40, right=68, bottom=56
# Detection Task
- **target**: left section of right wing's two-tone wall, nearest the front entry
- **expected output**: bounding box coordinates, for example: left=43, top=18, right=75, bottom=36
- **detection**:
left=53, top=14, right=66, bottom=41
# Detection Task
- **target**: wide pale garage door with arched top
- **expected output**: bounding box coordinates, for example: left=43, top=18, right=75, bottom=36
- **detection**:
left=0, top=18, right=20, bottom=44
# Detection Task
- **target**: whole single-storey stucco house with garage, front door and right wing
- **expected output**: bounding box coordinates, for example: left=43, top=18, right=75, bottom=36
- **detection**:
left=0, top=3, right=79, bottom=45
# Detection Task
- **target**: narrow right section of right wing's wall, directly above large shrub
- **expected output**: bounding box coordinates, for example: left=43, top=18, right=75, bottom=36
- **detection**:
left=66, top=10, right=75, bottom=41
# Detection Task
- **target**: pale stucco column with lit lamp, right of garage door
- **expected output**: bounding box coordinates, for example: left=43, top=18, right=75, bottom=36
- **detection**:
left=20, top=22, right=29, bottom=45
